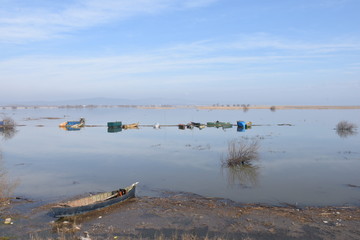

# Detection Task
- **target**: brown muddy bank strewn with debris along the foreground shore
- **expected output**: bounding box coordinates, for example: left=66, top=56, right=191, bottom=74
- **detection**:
left=0, top=193, right=360, bottom=240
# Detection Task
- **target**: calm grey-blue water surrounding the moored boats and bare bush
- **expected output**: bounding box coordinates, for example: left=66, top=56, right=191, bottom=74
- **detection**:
left=0, top=108, right=360, bottom=205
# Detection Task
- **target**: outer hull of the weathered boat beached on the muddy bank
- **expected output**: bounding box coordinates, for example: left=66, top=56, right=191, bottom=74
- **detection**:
left=49, top=183, right=137, bottom=218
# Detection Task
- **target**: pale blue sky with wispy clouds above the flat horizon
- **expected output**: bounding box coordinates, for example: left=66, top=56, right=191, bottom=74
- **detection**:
left=0, top=0, right=360, bottom=105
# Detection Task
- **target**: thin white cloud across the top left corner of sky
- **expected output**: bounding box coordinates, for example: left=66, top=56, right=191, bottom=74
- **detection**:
left=0, top=0, right=216, bottom=42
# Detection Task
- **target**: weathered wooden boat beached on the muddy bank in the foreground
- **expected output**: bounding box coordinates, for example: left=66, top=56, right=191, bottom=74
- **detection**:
left=49, top=182, right=138, bottom=217
